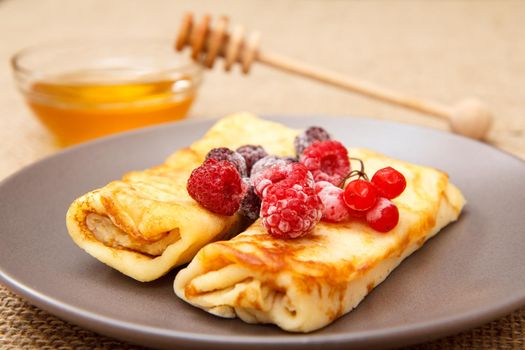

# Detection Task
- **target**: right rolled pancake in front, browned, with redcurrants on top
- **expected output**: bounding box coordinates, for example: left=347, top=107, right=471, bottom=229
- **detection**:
left=174, top=148, right=465, bottom=332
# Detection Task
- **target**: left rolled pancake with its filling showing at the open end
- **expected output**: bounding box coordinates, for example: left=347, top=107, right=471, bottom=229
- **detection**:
left=66, top=113, right=296, bottom=281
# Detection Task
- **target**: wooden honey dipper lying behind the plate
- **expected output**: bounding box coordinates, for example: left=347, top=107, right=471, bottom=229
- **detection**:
left=175, top=13, right=492, bottom=139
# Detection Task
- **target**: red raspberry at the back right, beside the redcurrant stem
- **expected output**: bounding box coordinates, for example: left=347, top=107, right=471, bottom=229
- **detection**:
left=299, top=140, right=350, bottom=186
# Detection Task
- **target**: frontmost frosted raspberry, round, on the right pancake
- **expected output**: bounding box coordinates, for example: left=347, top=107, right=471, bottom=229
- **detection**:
left=261, top=183, right=323, bottom=238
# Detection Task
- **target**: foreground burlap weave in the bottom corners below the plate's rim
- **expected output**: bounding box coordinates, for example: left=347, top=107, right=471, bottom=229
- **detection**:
left=0, top=285, right=525, bottom=350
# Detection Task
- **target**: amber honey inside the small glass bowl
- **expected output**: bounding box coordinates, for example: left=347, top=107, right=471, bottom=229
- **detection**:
left=26, top=71, right=196, bottom=146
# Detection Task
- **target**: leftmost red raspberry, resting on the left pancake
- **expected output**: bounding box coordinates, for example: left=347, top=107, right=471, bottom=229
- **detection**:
left=186, top=158, right=246, bottom=215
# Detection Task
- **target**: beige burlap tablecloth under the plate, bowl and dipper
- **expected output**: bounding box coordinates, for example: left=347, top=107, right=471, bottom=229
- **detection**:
left=0, top=0, right=525, bottom=349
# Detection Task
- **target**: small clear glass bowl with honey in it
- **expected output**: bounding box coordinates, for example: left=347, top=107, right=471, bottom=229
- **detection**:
left=12, top=40, right=201, bottom=146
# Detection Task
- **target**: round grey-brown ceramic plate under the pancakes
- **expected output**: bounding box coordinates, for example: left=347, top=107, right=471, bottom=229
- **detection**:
left=0, top=117, right=525, bottom=350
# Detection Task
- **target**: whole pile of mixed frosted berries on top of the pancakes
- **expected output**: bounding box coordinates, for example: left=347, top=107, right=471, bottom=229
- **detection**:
left=187, top=126, right=406, bottom=235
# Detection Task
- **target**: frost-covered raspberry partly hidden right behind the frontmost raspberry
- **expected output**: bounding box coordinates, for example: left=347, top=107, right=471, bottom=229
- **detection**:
left=252, top=163, right=314, bottom=198
